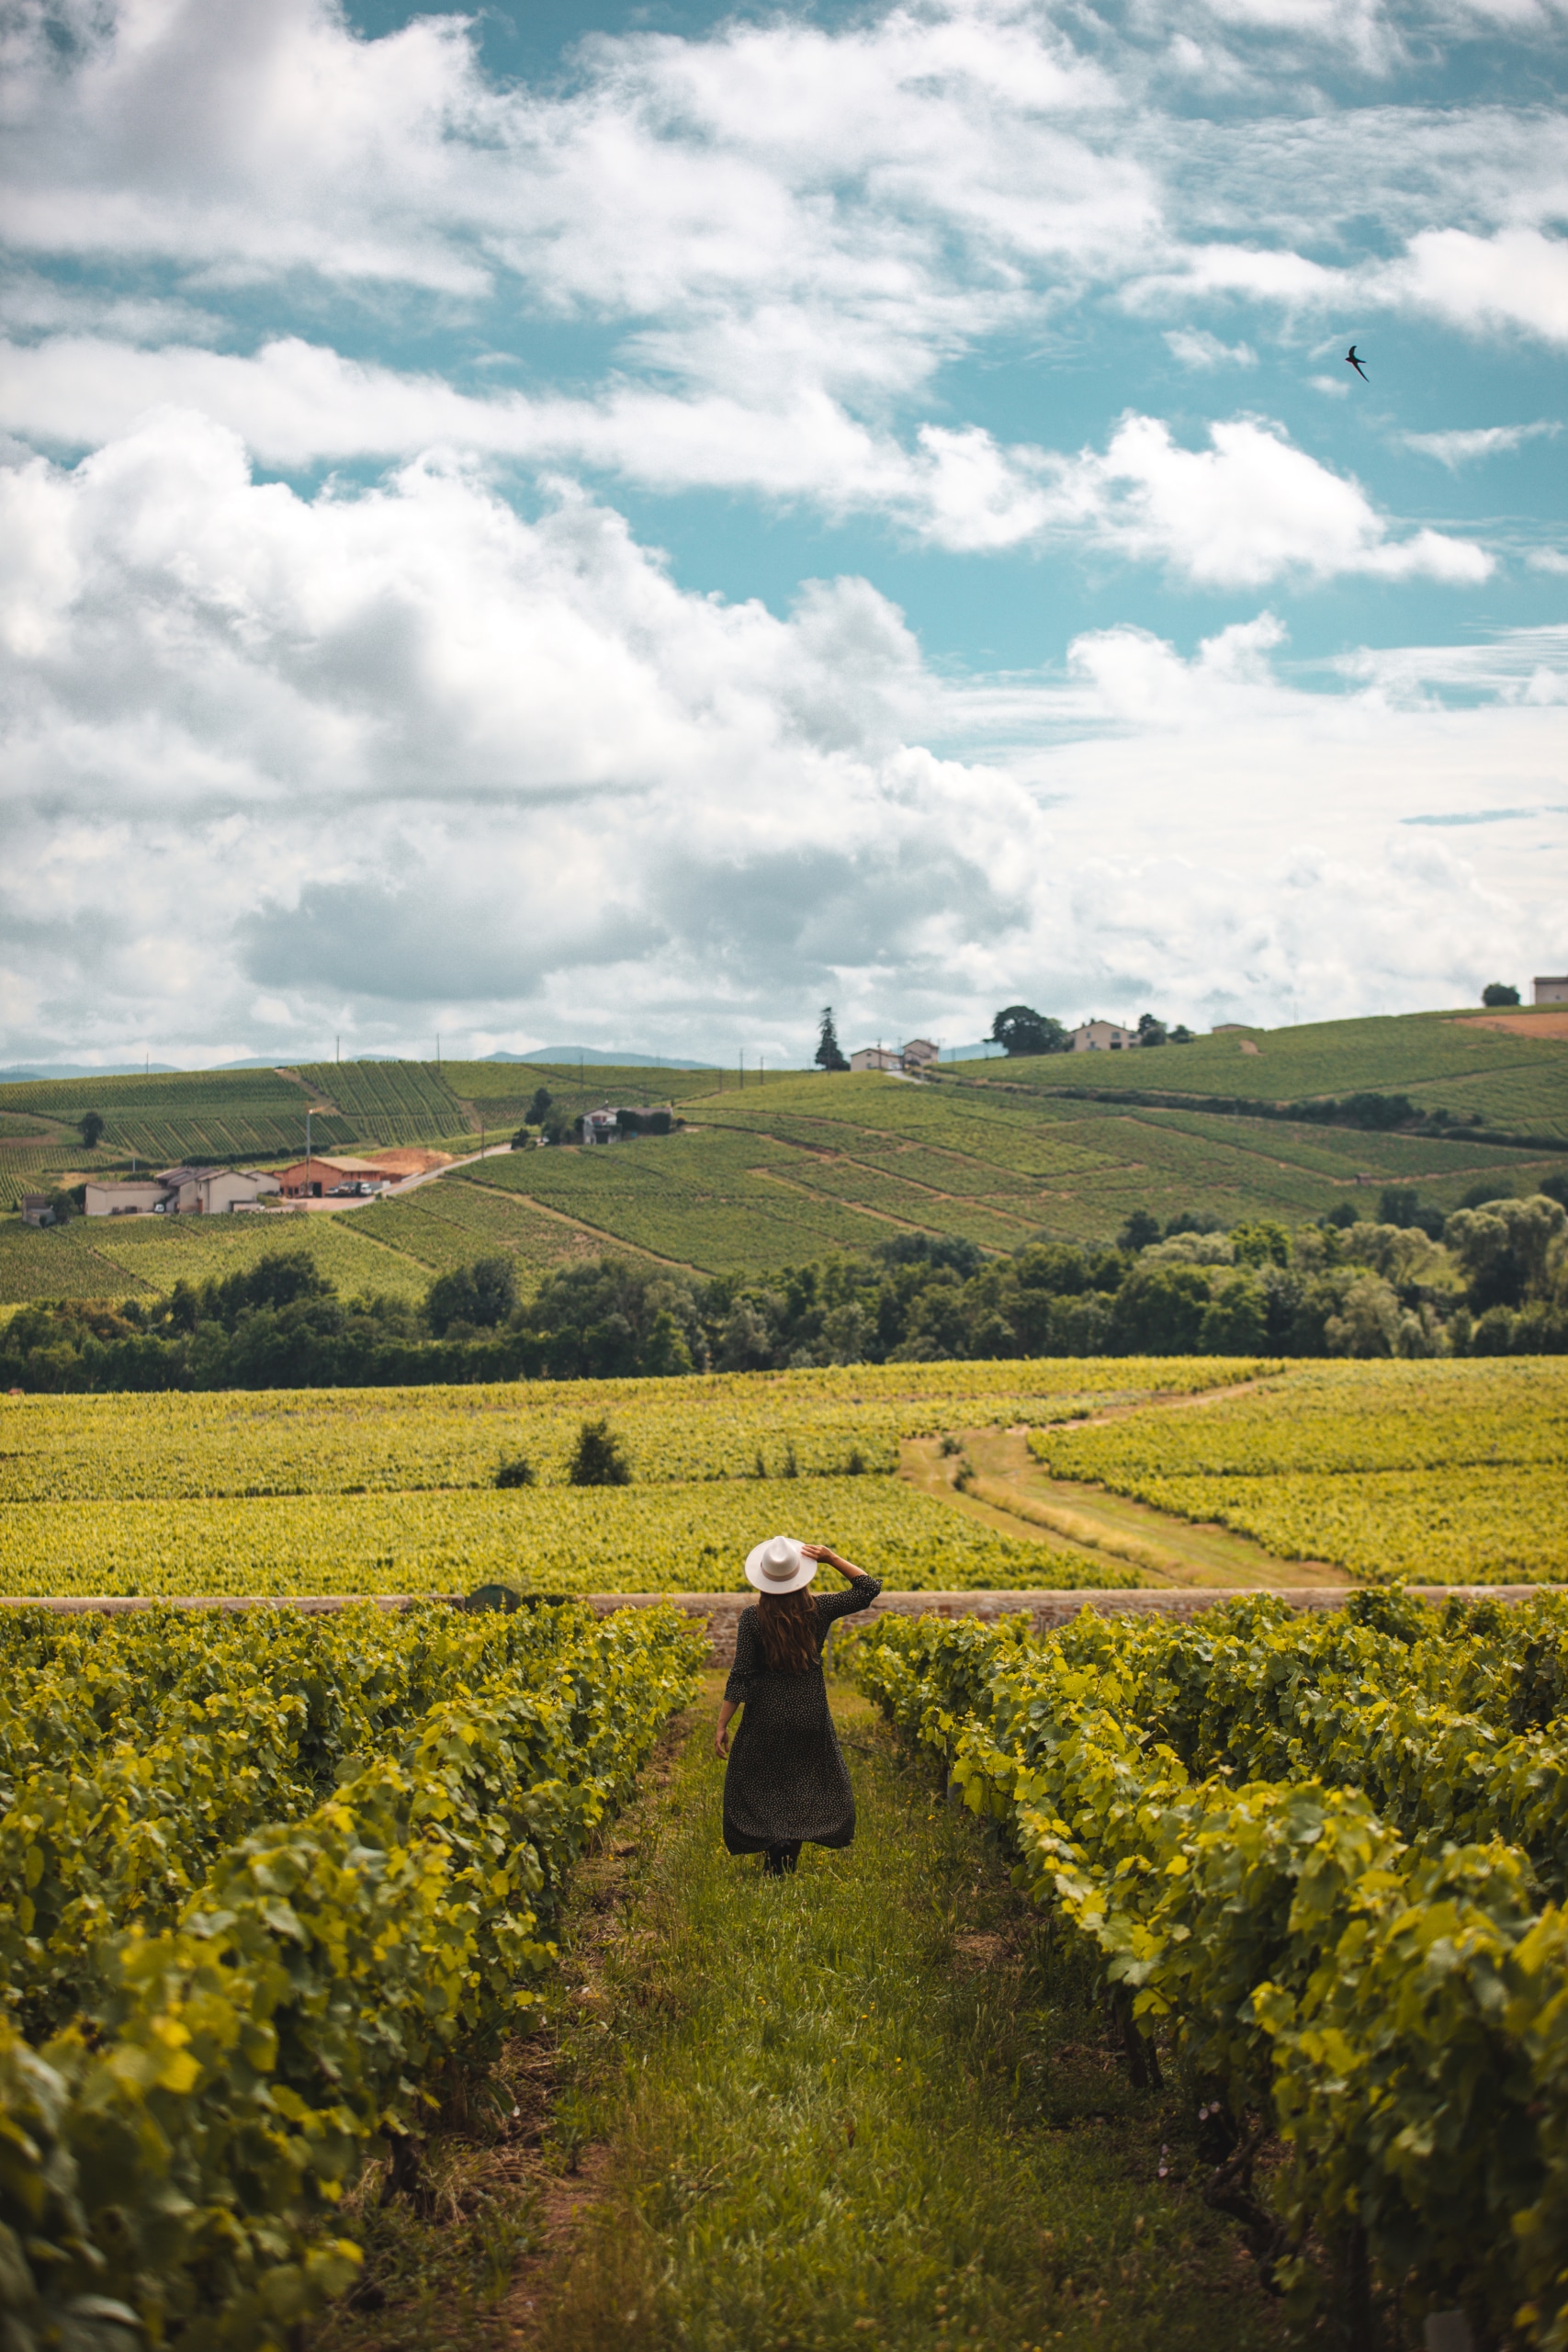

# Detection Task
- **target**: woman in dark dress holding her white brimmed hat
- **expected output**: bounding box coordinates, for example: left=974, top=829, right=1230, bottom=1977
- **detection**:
left=712, top=1536, right=882, bottom=1877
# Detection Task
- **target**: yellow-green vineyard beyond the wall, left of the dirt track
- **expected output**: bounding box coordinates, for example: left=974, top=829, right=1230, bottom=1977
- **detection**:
left=0, top=1357, right=1256, bottom=1592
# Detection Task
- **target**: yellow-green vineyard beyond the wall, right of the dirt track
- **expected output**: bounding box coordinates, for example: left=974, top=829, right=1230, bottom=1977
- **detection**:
left=1030, top=1357, right=1568, bottom=1585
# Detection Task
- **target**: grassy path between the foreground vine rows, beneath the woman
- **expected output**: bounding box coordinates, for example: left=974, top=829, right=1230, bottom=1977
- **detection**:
left=320, top=1677, right=1293, bottom=2352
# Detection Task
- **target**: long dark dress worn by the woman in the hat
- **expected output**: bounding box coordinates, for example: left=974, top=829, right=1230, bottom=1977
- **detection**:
left=724, top=1576, right=882, bottom=1853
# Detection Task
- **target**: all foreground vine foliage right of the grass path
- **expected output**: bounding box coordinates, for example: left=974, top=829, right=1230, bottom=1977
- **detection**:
left=856, top=1592, right=1568, bottom=2352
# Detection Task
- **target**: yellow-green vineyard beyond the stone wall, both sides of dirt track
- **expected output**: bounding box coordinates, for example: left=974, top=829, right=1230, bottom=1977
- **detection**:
left=0, top=1363, right=1568, bottom=1592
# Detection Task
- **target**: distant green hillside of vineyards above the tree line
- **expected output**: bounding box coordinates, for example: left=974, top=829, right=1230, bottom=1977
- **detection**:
left=0, top=1013, right=1568, bottom=1301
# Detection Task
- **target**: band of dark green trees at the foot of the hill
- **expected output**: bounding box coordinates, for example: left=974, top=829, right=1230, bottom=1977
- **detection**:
left=0, top=1176, right=1568, bottom=1390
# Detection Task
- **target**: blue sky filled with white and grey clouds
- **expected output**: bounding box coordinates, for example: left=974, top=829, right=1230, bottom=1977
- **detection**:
left=0, top=0, right=1568, bottom=1063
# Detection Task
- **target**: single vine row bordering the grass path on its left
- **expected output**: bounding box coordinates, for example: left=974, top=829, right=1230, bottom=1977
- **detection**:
left=0, top=1611, right=694, bottom=2352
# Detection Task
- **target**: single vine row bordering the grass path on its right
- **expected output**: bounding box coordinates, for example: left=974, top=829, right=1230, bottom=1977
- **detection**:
left=856, top=1618, right=1568, bottom=2352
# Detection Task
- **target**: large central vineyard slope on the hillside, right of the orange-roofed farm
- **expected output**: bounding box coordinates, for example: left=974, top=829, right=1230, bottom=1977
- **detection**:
left=460, top=1058, right=1556, bottom=1272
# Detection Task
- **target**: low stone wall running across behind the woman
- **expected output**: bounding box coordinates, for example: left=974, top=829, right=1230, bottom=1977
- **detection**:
left=0, top=1585, right=1568, bottom=1665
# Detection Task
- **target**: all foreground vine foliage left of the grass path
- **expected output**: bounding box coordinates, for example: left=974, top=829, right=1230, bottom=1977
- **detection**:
left=0, top=1604, right=701, bottom=2352
